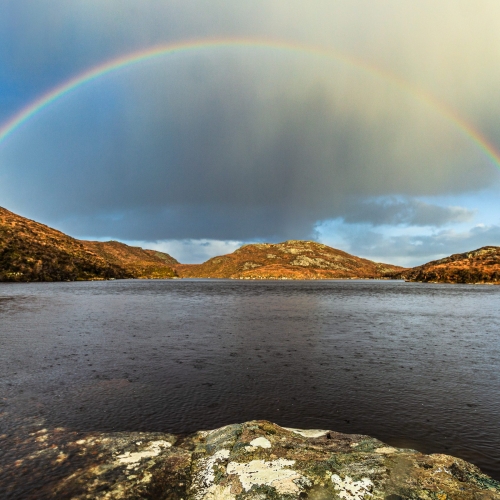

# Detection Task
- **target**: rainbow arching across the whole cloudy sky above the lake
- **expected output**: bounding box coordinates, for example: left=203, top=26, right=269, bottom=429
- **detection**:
left=0, top=38, right=500, bottom=169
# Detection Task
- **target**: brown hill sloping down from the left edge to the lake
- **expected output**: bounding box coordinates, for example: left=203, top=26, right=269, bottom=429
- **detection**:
left=0, top=207, right=177, bottom=281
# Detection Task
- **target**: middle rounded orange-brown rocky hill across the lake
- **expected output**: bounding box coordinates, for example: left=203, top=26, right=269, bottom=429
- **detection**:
left=175, top=240, right=403, bottom=279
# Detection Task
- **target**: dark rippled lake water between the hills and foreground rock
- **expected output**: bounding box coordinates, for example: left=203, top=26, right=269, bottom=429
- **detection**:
left=0, top=280, right=500, bottom=492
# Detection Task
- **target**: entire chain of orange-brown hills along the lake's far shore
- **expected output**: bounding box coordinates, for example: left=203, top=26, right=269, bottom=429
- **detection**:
left=0, top=207, right=500, bottom=285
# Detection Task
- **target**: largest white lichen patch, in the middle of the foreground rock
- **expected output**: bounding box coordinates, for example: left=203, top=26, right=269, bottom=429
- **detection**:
left=227, top=458, right=309, bottom=494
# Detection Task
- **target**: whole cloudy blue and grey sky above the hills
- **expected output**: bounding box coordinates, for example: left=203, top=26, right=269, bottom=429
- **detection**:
left=0, top=0, right=500, bottom=266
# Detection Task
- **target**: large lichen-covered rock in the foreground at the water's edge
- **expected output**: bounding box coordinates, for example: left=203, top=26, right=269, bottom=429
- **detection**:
left=11, top=421, right=500, bottom=500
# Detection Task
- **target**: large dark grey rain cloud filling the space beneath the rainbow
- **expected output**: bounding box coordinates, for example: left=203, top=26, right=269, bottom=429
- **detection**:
left=2, top=53, right=492, bottom=240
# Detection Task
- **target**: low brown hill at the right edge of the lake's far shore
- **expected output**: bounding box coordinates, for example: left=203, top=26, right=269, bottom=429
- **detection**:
left=391, top=246, right=500, bottom=284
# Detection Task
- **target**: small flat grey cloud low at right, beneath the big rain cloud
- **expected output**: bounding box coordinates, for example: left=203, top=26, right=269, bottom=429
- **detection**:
left=344, top=198, right=475, bottom=227
